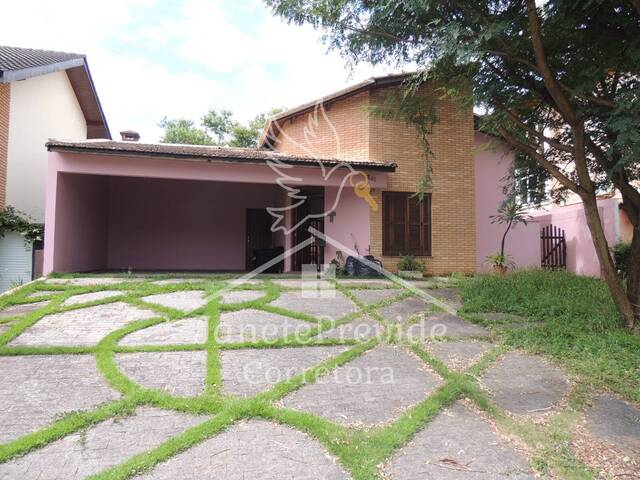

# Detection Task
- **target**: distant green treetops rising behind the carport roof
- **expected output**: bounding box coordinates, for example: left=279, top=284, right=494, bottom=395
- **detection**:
left=160, top=108, right=282, bottom=148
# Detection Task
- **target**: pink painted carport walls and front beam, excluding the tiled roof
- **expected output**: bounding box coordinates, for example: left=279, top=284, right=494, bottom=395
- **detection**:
left=44, top=152, right=386, bottom=274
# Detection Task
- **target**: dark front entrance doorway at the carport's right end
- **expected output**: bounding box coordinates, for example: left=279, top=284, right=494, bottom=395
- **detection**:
left=292, top=187, right=324, bottom=271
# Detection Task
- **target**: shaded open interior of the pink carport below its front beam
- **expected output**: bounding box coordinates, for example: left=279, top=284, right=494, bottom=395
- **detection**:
left=53, top=173, right=286, bottom=272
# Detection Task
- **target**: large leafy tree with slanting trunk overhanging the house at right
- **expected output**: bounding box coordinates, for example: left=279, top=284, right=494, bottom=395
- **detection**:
left=266, top=0, right=640, bottom=328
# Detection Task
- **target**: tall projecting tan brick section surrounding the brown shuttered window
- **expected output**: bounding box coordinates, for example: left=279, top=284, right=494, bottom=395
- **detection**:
left=370, top=85, right=476, bottom=275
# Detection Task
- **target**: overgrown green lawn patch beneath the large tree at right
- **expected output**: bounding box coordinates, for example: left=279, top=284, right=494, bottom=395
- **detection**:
left=461, top=270, right=640, bottom=402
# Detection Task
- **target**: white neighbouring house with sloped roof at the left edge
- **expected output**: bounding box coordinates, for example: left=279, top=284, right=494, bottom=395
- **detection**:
left=0, top=46, right=111, bottom=291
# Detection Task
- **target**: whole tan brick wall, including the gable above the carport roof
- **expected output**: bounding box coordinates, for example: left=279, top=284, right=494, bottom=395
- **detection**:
left=276, top=84, right=476, bottom=275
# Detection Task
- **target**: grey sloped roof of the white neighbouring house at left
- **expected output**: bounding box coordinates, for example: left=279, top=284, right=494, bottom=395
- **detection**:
left=0, top=46, right=111, bottom=139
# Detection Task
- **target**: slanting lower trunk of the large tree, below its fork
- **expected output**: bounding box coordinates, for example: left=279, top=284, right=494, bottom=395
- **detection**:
left=582, top=194, right=635, bottom=330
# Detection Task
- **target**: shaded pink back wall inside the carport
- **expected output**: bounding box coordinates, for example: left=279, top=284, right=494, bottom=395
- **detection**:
left=107, top=177, right=283, bottom=270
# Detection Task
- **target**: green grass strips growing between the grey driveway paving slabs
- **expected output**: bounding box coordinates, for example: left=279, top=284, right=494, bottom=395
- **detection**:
left=0, top=276, right=594, bottom=480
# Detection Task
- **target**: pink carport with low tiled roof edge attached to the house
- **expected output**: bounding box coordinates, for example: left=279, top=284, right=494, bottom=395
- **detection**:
left=44, top=141, right=393, bottom=274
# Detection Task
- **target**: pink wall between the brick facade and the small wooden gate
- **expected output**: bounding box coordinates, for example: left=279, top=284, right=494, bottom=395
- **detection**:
left=474, top=132, right=540, bottom=271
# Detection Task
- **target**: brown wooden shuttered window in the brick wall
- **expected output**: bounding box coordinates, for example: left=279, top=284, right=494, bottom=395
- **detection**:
left=382, top=192, right=431, bottom=256
